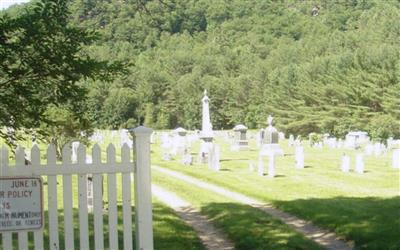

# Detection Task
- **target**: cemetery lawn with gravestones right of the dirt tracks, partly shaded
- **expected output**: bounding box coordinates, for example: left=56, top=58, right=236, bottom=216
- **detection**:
left=152, top=136, right=400, bottom=249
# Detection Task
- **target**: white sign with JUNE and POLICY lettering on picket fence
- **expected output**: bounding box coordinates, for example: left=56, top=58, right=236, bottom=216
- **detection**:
left=0, top=177, right=43, bottom=232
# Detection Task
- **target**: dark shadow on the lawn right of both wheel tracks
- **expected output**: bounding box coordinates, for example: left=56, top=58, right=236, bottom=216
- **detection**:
left=274, top=197, right=400, bottom=249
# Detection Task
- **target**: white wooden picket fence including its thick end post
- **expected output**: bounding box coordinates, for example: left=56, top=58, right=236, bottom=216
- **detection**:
left=0, top=127, right=153, bottom=250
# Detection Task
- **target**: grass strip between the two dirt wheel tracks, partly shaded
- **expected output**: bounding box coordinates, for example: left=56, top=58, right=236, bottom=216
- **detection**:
left=152, top=171, right=322, bottom=250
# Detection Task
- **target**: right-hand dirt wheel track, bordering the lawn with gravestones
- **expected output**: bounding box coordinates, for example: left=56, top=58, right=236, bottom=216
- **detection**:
left=152, top=166, right=353, bottom=250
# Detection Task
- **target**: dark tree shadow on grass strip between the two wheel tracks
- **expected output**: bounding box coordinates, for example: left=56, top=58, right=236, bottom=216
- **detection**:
left=201, top=203, right=322, bottom=250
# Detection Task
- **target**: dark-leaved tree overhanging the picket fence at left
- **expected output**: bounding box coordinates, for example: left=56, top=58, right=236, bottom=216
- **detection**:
left=0, top=0, right=120, bottom=148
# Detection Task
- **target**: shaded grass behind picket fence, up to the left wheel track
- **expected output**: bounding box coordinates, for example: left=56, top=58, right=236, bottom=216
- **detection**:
left=13, top=204, right=204, bottom=250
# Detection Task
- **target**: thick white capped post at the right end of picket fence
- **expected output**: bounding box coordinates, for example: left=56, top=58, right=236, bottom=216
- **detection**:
left=130, top=126, right=153, bottom=250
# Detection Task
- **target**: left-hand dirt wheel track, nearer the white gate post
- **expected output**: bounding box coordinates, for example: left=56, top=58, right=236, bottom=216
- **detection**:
left=152, top=184, right=235, bottom=250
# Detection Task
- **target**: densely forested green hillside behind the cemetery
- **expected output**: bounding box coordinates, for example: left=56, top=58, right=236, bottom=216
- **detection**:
left=6, top=0, right=400, bottom=138
